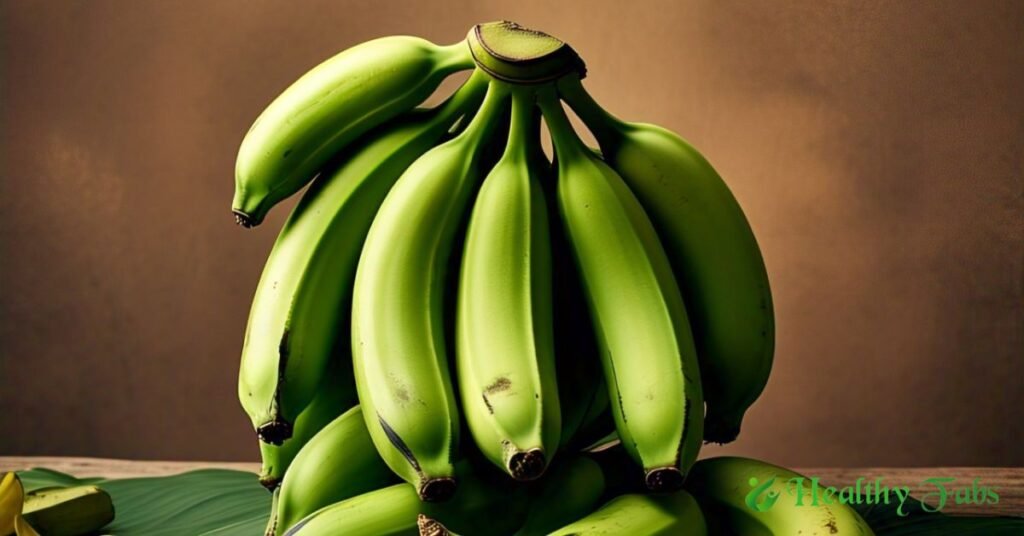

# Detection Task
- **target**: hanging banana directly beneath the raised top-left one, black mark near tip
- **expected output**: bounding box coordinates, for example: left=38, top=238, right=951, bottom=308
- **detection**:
left=239, top=73, right=487, bottom=445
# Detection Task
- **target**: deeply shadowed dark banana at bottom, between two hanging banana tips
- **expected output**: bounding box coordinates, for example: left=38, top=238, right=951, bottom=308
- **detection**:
left=515, top=456, right=604, bottom=536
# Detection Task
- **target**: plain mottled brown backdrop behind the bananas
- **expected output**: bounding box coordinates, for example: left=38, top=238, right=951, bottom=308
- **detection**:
left=0, top=0, right=1024, bottom=466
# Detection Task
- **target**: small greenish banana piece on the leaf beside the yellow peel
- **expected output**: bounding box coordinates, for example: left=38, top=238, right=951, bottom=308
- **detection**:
left=22, top=486, right=114, bottom=536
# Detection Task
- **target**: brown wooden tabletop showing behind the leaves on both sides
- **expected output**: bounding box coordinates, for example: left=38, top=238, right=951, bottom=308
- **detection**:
left=0, top=456, right=1024, bottom=516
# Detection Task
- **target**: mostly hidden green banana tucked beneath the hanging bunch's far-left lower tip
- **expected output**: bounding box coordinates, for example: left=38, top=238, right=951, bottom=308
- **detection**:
left=259, top=362, right=355, bottom=490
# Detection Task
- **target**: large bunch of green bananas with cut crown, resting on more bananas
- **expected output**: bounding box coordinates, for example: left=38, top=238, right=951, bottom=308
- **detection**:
left=232, top=22, right=855, bottom=535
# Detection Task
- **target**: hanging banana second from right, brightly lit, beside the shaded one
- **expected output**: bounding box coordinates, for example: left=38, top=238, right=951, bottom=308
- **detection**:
left=540, top=92, right=703, bottom=490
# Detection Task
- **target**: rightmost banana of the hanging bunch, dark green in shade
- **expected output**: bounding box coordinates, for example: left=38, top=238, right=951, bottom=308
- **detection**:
left=559, top=76, right=775, bottom=443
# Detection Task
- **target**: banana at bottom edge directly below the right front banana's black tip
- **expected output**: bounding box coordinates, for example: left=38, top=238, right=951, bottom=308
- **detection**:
left=551, top=490, right=708, bottom=536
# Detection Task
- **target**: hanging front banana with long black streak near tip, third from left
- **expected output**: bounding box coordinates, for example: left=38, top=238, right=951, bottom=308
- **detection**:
left=352, top=79, right=508, bottom=501
